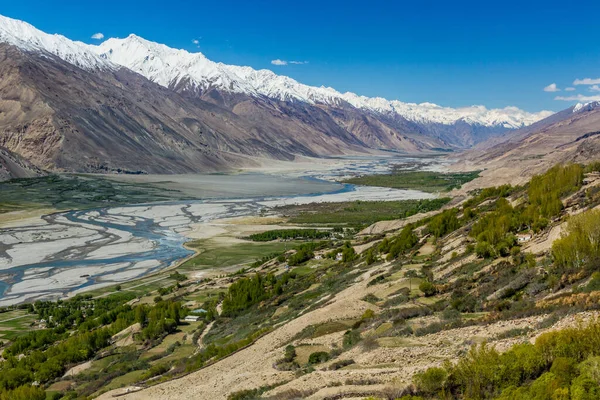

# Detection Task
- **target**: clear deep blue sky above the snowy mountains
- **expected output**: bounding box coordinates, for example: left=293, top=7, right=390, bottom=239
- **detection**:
left=0, top=0, right=600, bottom=111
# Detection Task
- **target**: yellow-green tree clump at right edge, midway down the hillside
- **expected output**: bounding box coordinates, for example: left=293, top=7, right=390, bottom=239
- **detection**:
left=552, top=210, right=600, bottom=273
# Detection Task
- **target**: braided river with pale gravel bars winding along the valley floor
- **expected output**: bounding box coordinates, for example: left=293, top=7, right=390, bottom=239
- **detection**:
left=0, top=155, right=442, bottom=306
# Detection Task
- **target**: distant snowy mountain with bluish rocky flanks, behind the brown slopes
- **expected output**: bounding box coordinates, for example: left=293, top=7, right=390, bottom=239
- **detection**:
left=95, top=35, right=552, bottom=150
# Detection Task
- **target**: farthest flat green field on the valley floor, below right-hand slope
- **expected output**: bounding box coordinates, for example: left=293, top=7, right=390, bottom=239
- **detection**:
left=343, top=170, right=479, bottom=193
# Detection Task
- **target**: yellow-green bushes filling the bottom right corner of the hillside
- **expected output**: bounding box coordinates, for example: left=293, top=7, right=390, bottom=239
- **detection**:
left=414, top=320, right=600, bottom=400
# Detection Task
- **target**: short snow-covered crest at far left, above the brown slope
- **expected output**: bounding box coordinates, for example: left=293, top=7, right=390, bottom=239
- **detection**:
left=0, top=15, right=114, bottom=70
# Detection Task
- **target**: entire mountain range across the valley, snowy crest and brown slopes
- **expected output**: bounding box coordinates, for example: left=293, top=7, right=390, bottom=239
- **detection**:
left=0, top=16, right=568, bottom=180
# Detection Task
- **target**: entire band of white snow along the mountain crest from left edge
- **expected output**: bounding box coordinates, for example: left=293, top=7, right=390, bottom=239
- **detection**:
left=0, top=16, right=552, bottom=128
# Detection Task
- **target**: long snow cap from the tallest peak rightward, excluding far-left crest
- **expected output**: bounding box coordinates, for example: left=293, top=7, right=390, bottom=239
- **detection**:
left=92, top=35, right=552, bottom=129
